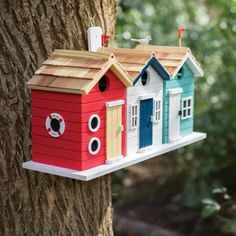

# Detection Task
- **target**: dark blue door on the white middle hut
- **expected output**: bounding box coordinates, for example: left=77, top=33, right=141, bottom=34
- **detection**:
left=139, top=98, right=153, bottom=148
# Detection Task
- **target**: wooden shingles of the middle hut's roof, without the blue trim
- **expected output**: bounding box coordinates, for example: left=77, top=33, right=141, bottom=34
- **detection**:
left=98, top=48, right=155, bottom=81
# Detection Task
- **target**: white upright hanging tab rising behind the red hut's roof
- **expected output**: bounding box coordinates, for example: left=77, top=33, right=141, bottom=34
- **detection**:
left=88, top=26, right=102, bottom=52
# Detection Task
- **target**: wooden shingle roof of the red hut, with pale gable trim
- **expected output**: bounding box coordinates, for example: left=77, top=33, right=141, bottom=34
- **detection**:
left=27, top=50, right=132, bottom=94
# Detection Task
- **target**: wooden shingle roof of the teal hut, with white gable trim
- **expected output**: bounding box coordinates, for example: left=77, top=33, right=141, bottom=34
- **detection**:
left=136, top=44, right=203, bottom=77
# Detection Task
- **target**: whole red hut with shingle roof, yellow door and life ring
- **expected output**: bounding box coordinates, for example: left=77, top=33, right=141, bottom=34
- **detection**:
left=28, top=50, right=132, bottom=171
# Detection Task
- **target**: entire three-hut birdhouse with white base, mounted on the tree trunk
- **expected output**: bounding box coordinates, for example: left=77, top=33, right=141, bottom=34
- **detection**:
left=23, top=27, right=206, bottom=180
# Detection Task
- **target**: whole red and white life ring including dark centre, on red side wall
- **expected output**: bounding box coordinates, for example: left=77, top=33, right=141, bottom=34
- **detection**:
left=45, top=113, right=65, bottom=138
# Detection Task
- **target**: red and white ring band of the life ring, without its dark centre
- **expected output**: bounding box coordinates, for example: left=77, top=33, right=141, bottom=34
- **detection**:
left=45, top=113, right=65, bottom=138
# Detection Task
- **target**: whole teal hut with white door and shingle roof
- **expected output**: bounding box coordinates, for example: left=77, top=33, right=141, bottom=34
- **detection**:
left=137, top=45, right=203, bottom=144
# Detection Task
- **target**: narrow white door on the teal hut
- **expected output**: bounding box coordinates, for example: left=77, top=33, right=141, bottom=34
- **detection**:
left=169, top=88, right=183, bottom=142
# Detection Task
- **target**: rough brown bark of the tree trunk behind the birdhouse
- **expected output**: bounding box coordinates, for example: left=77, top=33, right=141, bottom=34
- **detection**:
left=0, top=0, right=117, bottom=236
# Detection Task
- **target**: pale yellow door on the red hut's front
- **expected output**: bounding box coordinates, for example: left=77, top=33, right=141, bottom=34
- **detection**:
left=106, top=103, right=123, bottom=163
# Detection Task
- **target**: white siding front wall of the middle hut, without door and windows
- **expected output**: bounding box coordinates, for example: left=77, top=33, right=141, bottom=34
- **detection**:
left=127, top=66, right=163, bottom=156
